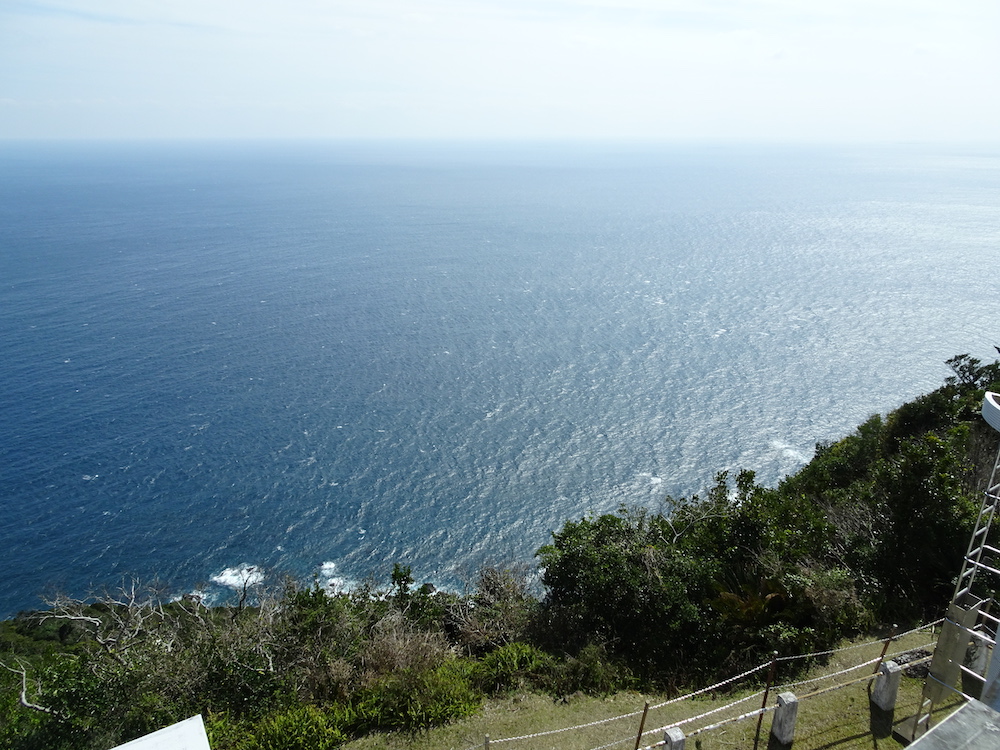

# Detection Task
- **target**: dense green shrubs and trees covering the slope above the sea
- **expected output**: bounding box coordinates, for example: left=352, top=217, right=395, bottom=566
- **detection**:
left=0, top=355, right=1000, bottom=750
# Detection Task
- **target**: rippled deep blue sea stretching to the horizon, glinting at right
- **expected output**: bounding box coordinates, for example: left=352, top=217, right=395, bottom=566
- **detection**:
left=0, top=143, right=1000, bottom=616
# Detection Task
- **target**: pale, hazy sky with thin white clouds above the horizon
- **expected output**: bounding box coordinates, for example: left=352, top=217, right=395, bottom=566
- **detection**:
left=0, top=0, right=1000, bottom=143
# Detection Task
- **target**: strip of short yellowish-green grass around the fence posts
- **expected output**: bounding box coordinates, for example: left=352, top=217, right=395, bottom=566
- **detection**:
left=345, top=630, right=958, bottom=750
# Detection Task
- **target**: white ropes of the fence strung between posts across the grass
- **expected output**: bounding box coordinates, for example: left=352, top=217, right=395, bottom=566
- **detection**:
left=468, top=618, right=944, bottom=750
